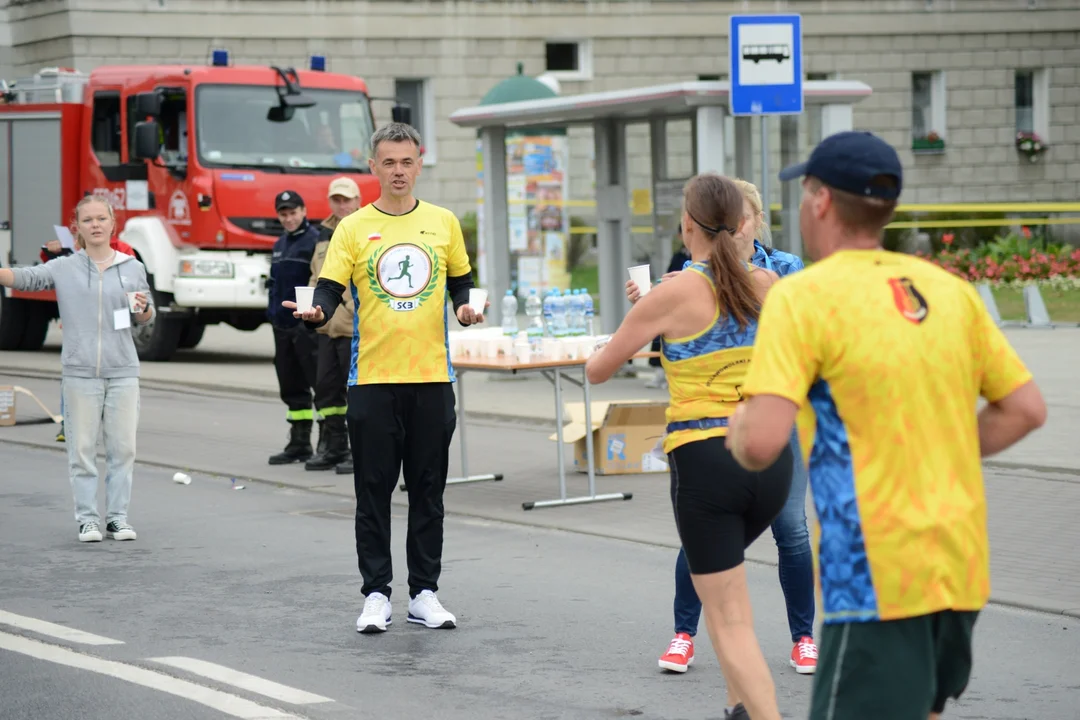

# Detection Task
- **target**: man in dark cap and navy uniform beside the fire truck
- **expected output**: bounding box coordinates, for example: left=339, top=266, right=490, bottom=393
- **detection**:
left=268, top=190, right=320, bottom=465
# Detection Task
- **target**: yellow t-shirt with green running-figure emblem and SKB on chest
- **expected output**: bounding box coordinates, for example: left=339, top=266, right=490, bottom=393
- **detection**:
left=320, top=201, right=470, bottom=385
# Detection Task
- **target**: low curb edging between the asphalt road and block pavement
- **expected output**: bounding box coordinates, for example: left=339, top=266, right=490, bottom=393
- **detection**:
left=0, top=439, right=1080, bottom=620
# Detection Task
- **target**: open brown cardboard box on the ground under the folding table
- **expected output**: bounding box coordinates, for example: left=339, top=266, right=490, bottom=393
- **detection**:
left=550, top=400, right=667, bottom=475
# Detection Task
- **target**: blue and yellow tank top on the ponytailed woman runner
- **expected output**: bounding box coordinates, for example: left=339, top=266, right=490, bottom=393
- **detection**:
left=660, top=262, right=757, bottom=452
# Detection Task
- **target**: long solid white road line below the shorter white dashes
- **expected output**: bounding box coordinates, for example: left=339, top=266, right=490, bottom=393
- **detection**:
left=0, top=631, right=303, bottom=720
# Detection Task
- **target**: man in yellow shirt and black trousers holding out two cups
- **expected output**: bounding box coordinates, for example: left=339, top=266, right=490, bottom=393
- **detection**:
left=286, top=123, right=484, bottom=633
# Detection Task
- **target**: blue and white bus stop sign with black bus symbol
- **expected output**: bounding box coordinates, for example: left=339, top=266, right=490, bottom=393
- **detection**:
left=728, top=15, right=802, bottom=116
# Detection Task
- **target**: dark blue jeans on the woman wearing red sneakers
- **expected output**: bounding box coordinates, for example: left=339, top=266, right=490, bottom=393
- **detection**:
left=675, top=432, right=814, bottom=642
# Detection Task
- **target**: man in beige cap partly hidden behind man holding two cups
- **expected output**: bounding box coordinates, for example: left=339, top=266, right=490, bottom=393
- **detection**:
left=303, top=177, right=360, bottom=475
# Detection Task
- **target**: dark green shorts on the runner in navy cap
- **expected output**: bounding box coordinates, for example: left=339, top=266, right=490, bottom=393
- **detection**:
left=810, top=610, right=978, bottom=720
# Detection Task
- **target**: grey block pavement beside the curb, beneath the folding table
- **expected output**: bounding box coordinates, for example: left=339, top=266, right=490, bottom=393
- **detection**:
left=0, top=371, right=1080, bottom=616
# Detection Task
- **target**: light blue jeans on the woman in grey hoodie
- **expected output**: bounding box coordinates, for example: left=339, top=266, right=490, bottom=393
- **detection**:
left=60, top=377, right=139, bottom=526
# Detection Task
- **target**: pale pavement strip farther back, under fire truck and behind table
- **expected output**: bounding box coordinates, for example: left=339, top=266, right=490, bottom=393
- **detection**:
left=0, top=324, right=1080, bottom=474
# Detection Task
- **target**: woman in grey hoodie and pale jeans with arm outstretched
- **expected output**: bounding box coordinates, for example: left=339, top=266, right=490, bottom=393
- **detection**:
left=0, top=195, right=154, bottom=542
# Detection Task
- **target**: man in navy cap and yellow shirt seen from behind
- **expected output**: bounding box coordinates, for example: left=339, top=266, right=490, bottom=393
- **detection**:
left=728, top=132, right=1047, bottom=720
